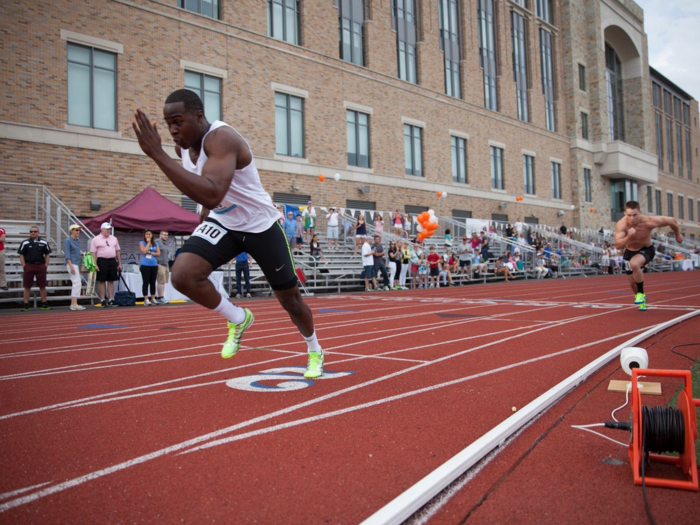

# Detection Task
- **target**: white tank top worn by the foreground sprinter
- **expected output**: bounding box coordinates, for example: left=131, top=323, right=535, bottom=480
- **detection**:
left=180, top=120, right=280, bottom=233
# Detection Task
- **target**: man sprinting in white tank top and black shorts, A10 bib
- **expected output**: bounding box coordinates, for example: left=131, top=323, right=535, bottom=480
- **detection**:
left=133, top=89, right=323, bottom=379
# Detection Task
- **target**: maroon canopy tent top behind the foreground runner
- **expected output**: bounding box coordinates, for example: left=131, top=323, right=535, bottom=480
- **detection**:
left=83, top=187, right=199, bottom=234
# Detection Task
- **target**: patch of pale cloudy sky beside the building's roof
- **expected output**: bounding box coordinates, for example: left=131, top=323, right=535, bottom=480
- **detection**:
left=635, top=0, right=700, bottom=99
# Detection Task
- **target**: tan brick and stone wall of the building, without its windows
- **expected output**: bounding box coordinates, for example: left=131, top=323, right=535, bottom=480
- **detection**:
left=0, top=0, right=700, bottom=233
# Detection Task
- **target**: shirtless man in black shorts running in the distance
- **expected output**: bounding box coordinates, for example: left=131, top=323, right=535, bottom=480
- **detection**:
left=615, top=201, right=683, bottom=311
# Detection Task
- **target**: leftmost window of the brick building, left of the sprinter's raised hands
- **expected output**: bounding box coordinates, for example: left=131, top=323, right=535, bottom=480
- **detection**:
left=68, top=44, right=117, bottom=130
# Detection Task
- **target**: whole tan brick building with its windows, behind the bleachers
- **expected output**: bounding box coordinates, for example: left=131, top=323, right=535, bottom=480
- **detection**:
left=0, top=0, right=700, bottom=233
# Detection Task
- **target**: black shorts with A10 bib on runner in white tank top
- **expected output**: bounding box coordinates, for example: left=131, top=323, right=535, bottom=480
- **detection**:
left=180, top=217, right=297, bottom=290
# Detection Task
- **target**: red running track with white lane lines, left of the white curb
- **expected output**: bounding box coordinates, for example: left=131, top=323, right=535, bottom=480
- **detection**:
left=0, top=272, right=700, bottom=523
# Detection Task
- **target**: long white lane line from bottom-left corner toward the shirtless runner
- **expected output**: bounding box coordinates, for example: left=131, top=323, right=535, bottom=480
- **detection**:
left=0, top=310, right=640, bottom=512
